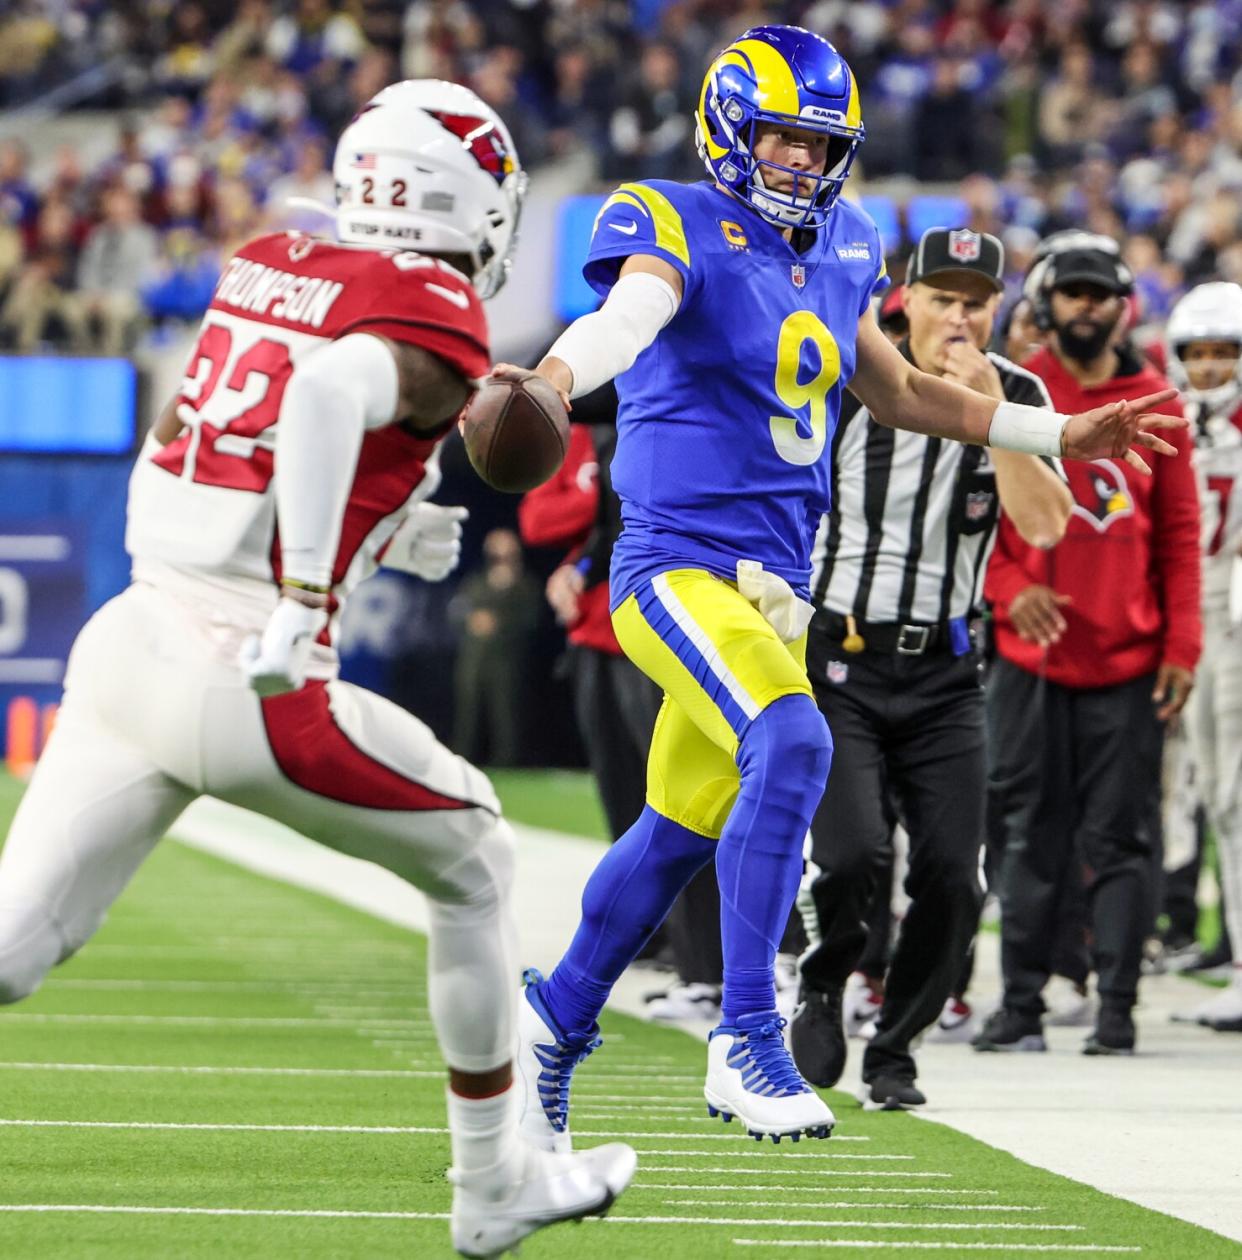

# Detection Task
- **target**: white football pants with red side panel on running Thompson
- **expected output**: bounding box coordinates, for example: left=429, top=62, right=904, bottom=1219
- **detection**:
left=0, top=582, right=518, bottom=1072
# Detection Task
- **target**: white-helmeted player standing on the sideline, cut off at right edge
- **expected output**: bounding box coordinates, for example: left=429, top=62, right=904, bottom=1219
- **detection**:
left=1165, top=282, right=1242, bottom=1032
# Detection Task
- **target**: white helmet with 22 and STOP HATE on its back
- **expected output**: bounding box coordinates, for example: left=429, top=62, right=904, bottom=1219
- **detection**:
left=333, top=79, right=527, bottom=297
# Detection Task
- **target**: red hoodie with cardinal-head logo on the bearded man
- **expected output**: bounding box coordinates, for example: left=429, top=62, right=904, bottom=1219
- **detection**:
left=984, top=350, right=1203, bottom=687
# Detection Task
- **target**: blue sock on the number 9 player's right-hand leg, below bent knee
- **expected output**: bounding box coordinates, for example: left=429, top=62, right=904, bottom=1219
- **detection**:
left=715, top=696, right=833, bottom=1024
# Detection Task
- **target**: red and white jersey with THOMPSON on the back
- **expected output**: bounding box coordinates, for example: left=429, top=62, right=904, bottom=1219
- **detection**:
left=126, top=233, right=490, bottom=660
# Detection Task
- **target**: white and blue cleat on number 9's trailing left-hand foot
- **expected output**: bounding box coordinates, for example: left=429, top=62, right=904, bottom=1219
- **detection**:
left=515, top=968, right=603, bottom=1155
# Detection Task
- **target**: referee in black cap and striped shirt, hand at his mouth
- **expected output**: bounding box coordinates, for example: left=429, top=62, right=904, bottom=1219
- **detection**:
left=791, top=228, right=1072, bottom=1110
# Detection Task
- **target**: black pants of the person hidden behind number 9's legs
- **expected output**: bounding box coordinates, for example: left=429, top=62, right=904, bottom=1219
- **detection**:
left=569, top=646, right=724, bottom=984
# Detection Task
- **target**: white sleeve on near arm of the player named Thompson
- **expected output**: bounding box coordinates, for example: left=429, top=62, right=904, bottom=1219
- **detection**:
left=276, top=334, right=398, bottom=586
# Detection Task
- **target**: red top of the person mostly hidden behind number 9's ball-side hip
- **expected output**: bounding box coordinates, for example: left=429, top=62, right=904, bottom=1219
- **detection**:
left=518, top=425, right=621, bottom=656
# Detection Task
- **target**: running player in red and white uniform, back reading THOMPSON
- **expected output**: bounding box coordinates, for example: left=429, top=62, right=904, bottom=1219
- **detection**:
left=0, top=81, right=635, bottom=1256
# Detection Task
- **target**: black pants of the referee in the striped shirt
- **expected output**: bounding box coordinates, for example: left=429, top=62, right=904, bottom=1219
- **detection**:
left=802, top=630, right=986, bottom=1080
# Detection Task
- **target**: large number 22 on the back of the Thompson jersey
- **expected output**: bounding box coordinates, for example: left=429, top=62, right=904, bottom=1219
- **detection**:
left=152, top=321, right=293, bottom=494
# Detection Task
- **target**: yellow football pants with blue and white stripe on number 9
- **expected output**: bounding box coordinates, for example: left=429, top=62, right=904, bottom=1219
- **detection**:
left=612, top=568, right=811, bottom=839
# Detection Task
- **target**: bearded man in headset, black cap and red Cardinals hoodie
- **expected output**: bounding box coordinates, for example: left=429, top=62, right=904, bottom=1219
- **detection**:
left=974, top=233, right=1203, bottom=1055
